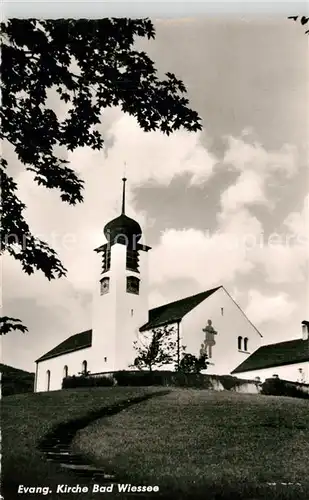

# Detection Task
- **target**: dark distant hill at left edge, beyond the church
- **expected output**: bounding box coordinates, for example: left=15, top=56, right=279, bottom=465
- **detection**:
left=0, top=363, right=34, bottom=396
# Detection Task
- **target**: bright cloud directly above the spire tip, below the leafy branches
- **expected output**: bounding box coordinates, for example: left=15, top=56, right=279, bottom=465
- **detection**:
left=104, top=115, right=217, bottom=186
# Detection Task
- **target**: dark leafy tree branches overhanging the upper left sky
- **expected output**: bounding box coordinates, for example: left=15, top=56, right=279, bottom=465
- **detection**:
left=0, top=18, right=202, bottom=334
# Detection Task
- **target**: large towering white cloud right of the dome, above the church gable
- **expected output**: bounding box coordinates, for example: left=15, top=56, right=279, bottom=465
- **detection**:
left=151, top=134, right=308, bottom=296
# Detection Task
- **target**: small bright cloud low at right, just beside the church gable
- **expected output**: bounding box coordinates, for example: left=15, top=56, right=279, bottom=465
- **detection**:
left=245, top=290, right=297, bottom=326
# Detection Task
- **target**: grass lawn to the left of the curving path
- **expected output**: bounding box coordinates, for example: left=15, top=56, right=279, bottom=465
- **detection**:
left=1, top=387, right=164, bottom=500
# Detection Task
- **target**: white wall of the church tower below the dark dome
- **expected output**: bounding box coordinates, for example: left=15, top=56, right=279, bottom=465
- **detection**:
left=91, top=243, right=148, bottom=373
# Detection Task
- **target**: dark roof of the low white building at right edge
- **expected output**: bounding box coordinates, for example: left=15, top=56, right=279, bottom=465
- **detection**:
left=231, top=339, right=309, bottom=373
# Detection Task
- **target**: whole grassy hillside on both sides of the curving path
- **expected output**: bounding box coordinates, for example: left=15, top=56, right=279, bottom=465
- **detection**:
left=1, top=387, right=309, bottom=500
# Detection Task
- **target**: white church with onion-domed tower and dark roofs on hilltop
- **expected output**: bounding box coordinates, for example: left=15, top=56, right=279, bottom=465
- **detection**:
left=35, top=178, right=309, bottom=392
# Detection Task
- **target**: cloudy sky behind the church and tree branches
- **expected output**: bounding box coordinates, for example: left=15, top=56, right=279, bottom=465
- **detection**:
left=2, top=17, right=309, bottom=371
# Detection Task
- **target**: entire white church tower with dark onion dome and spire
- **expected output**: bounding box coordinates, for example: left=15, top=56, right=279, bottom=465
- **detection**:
left=91, top=178, right=151, bottom=373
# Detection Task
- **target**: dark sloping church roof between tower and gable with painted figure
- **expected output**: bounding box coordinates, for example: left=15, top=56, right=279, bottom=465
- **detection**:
left=139, top=286, right=221, bottom=332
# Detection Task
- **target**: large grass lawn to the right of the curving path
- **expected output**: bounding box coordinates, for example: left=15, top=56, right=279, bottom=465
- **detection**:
left=73, top=389, right=309, bottom=500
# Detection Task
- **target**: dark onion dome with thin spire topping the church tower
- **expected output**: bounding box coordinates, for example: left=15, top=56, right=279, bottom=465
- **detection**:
left=104, top=177, right=142, bottom=247
